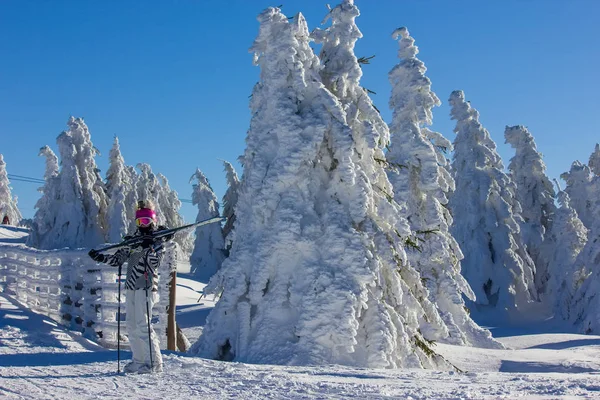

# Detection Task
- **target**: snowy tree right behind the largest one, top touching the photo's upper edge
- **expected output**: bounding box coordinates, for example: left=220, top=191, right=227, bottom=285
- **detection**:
left=312, top=0, right=448, bottom=346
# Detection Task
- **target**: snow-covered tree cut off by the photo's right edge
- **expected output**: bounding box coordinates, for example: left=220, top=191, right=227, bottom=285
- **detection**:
left=571, top=175, right=600, bottom=334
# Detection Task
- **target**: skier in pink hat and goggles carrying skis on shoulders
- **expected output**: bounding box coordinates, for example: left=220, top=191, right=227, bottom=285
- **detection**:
left=89, top=200, right=173, bottom=373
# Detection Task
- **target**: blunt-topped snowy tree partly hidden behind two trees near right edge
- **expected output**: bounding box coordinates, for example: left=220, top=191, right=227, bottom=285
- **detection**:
left=560, top=161, right=595, bottom=229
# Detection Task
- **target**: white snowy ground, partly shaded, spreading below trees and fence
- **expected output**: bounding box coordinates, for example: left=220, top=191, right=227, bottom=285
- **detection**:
left=0, top=228, right=600, bottom=400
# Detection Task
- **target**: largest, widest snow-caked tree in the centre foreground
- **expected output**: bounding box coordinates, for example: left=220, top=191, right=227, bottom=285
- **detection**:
left=192, top=3, right=452, bottom=368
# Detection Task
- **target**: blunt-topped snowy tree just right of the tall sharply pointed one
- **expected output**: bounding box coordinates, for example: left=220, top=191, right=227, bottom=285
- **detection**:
left=504, top=125, right=556, bottom=293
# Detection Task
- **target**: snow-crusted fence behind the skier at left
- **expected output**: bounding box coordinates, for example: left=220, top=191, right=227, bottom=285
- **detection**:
left=0, top=245, right=177, bottom=347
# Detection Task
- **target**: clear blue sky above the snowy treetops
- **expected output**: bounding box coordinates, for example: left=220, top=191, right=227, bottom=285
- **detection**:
left=0, top=0, right=600, bottom=221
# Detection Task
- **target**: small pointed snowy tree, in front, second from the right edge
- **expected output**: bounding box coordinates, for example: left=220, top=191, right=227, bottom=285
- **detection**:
left=543, top=190, right=587, bottom=320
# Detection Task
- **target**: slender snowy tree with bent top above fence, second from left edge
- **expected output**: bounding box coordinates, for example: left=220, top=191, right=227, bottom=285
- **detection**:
left=27, top=146, right=60, bottom=248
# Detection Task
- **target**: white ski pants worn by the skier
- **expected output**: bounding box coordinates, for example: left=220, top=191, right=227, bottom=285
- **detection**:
left=125, top=289, right=162, bottom=367
